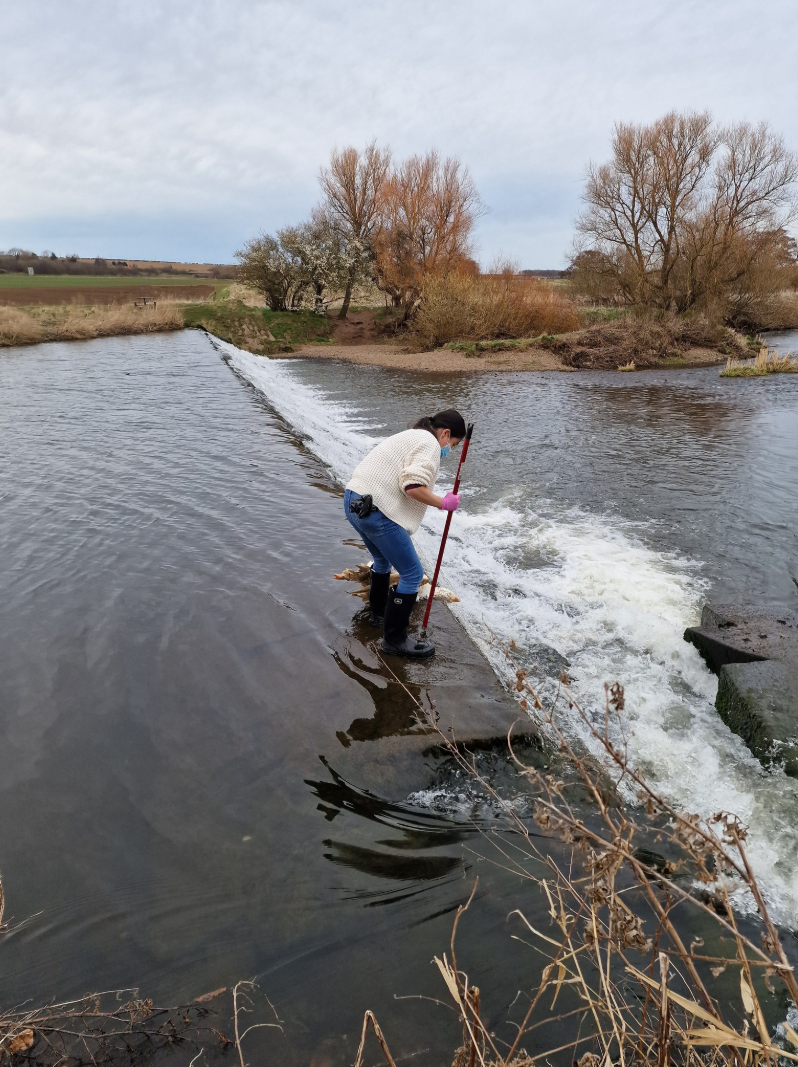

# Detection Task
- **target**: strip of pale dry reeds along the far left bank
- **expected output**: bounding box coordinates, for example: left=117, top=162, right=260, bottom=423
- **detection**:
left=0, top=301, right=183, bottom=346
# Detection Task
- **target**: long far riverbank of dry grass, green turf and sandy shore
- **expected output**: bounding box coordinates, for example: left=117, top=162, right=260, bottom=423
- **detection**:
left=0, top=294, right=752, bottom=373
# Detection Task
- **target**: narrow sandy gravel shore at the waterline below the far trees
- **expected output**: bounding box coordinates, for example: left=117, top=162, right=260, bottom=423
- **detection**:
left=281, top=344, right=725, bottom=373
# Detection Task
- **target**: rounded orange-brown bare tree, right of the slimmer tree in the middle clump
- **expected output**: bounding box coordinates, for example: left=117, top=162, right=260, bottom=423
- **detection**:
left=374, top=152, right=483, bottom=319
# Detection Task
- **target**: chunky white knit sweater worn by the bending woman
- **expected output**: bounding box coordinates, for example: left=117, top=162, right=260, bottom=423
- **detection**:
left=347, top=430, right=441, bottom=534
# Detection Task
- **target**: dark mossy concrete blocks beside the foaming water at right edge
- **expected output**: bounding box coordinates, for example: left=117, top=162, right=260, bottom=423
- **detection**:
left=685, top=604, right=798, bottom=778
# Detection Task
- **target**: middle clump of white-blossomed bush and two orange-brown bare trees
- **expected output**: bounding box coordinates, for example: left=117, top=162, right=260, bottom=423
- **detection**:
left=236, top=142, right=482, bottom=323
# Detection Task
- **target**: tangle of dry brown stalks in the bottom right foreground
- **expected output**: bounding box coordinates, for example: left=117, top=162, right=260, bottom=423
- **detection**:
left=358, top=646, right=798, bottom=1067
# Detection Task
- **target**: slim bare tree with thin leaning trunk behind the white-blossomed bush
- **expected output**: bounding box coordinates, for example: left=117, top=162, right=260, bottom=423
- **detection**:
left=319, top=141, right=390, bottom=319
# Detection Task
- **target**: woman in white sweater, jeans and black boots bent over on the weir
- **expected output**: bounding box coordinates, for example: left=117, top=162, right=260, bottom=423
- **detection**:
left=344, top=408, right=465, bottom=659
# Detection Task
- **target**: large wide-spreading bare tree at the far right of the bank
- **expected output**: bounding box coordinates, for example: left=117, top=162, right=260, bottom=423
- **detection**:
left=572, top=112, right=798, bottom=319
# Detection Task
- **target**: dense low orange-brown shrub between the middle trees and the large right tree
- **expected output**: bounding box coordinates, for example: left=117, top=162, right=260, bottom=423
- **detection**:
left=409, top=270, right=581, bottom=350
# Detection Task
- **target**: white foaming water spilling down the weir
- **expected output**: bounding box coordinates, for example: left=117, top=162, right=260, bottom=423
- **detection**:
left=220, top=341, right=798, bottom=928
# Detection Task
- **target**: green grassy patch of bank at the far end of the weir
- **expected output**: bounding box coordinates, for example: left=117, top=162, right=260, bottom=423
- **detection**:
left=182, top=300, right=333, bottom=355
